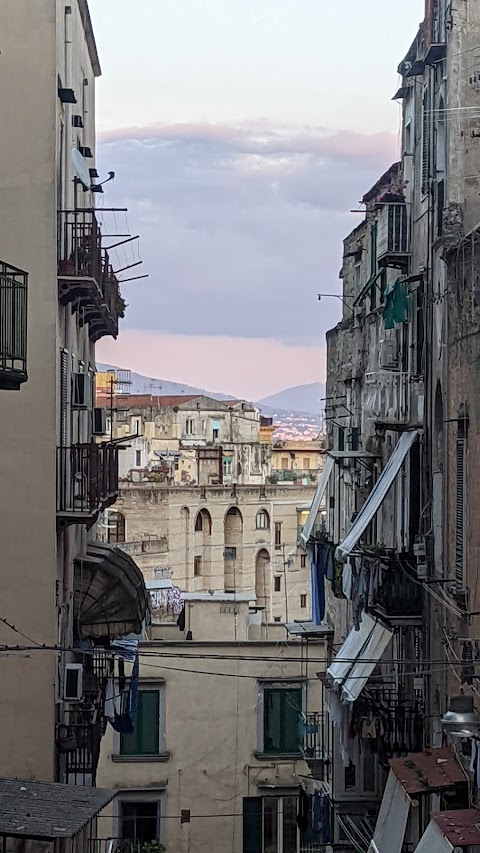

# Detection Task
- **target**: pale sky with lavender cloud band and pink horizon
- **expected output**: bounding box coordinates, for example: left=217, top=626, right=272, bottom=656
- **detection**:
left=90, top=0, right=424, bottom=400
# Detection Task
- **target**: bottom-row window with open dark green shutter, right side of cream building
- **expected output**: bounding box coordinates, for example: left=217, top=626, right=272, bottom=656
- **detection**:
left=243, top=796, right=298, bottom=853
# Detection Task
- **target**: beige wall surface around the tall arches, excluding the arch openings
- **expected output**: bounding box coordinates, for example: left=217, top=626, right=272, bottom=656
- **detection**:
left=107, top=483, right=315, bottom=621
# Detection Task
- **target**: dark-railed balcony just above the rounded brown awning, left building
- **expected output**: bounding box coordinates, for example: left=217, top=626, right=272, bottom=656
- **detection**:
left=57, top=443, right=118, bottom=527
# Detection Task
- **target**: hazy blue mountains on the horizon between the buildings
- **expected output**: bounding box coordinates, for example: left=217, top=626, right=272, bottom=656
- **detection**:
left=97, top=364, right=324, bottom=439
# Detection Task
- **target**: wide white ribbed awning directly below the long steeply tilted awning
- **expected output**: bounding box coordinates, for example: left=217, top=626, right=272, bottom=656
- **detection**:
left=327, top=613, right=393, bottom=704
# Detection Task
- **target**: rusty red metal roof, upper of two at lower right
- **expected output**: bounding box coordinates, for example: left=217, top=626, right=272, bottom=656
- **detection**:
left=390, top=746, right=466, bottom=795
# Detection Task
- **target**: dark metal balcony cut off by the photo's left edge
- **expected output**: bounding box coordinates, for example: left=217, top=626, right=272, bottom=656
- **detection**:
left=0, top=261, right=28, bottom=391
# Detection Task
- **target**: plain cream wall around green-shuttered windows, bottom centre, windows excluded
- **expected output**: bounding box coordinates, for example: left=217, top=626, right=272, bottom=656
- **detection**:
left=98, top=628, right=325, bottom=853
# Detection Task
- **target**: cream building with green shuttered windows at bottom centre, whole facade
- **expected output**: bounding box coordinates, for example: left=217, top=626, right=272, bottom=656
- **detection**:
left=98, top=594, right=330, bottom=853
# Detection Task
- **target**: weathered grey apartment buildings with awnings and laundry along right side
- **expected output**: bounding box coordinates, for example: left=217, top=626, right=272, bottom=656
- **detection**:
left=298, top=0, right=480, bottom=853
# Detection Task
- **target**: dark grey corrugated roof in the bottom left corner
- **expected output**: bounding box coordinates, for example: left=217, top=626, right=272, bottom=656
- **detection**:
left=0, top=779, right=115, bottom=840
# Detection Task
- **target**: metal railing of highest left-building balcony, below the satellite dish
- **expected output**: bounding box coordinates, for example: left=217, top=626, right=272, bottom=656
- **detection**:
left=58, top=208, right=102, bottom=283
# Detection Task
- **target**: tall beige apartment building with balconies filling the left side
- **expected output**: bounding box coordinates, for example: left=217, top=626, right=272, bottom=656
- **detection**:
left=0, top=0, right=148, bottom=792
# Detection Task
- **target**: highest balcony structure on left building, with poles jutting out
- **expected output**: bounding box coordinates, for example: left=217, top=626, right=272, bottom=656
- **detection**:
left=58, top=208, right=125, bottom=342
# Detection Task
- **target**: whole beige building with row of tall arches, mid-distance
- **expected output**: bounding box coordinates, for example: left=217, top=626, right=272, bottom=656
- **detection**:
left=97, top=482, right=322, bottom=623
